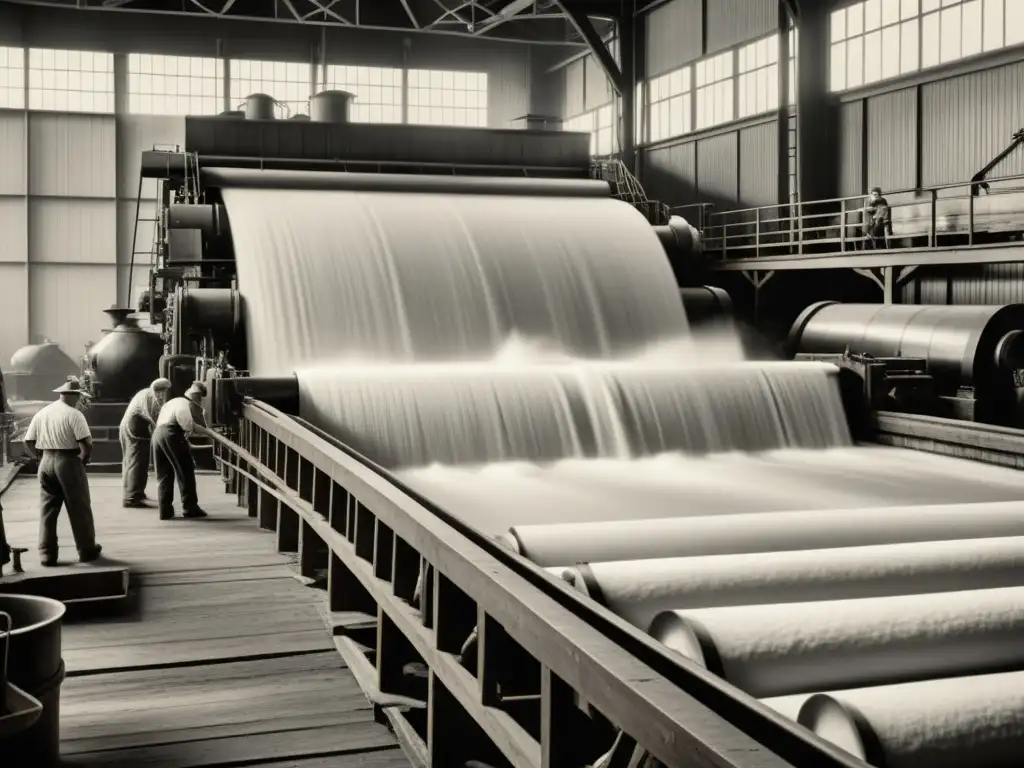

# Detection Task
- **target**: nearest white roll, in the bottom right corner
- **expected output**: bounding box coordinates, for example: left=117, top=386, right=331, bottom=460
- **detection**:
left=798, top=672, right=1024, bottom=768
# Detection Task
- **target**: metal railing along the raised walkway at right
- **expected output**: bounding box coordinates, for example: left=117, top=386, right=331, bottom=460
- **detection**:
left=700, top=175, right=1024, bottom=259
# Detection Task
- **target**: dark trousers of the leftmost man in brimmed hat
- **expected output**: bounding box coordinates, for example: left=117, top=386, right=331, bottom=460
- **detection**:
left=38, top=449, right=96, bottom=560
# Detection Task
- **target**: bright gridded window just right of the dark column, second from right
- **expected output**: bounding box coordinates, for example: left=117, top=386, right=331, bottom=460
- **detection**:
left=829, top=0, right=921, bottom=91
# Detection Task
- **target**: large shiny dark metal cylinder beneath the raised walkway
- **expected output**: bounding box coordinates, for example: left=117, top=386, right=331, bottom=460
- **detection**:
left=790, top=301, right=1024, bottom=423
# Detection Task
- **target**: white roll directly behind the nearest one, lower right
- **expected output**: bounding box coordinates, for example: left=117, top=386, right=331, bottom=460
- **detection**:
left=650, top=587, right=1024, bottom=698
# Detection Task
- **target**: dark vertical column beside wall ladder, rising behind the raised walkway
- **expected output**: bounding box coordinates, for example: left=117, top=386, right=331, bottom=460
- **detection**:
left=797, top=3, right=840, bottom=202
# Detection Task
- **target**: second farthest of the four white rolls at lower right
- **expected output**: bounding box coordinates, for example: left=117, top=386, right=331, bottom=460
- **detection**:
left=562, top=537, right=1024, bottom=630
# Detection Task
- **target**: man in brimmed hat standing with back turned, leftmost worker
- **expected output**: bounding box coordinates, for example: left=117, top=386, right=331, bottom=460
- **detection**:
left=25, top=376, right=103, bottom=566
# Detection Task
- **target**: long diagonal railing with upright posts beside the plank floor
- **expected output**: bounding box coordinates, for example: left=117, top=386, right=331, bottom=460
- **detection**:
left=201, top=401, right=861, bottom=768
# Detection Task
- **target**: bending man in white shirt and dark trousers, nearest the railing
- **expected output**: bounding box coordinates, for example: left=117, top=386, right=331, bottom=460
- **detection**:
left=153, top=381, right=207, bottom=520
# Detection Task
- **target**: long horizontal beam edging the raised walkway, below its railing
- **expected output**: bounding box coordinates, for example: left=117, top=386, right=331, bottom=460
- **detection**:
left=709, top=244, right=1024, bottom=272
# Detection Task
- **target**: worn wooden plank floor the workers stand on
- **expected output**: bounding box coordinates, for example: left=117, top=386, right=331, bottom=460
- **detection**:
left=3, top=475, right=409, bottom=768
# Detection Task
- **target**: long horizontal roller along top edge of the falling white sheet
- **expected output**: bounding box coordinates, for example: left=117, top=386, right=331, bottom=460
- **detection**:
left=202, top=167, right=609, bottom=198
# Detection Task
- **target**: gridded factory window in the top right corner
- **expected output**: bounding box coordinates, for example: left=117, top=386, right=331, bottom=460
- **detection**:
left=921, top=0, right=1024, bottom=67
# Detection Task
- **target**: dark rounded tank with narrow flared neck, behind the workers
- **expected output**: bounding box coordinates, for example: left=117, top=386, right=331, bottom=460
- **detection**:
left=86, top=307, right=164, bottom=401
